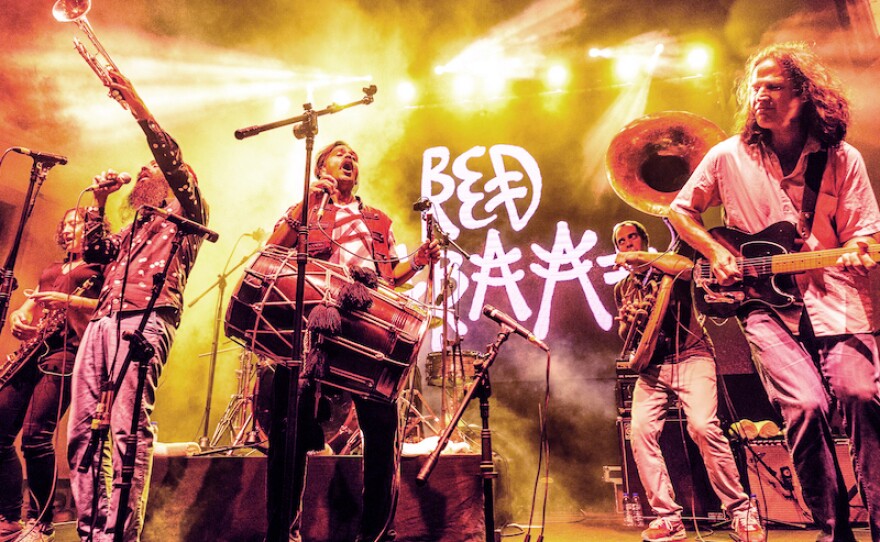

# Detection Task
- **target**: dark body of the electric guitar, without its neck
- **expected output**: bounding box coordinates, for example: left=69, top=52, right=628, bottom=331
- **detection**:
left=692, top=222, right=800, bottom=318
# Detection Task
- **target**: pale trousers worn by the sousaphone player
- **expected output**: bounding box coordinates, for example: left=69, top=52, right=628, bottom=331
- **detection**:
left=631, top=356, right=749, bottom=518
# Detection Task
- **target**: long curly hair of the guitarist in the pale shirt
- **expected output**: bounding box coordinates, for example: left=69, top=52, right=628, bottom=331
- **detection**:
left=736, top=42, right=850, bottom=147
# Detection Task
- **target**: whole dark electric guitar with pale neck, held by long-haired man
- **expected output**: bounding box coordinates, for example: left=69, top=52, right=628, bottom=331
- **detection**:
left=692, top=221, right=880, bottom=318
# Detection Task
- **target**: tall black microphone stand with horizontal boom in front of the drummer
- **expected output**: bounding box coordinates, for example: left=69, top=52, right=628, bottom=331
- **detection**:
left=235, top=85, right=376, bottom=542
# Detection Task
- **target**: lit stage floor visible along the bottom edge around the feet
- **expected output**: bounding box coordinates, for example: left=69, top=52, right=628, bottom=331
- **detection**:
left=49, top=516, right=852, bottom=542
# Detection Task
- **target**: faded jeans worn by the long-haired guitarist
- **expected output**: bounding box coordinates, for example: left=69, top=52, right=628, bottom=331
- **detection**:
left=741, top=310, right=880, bottom=541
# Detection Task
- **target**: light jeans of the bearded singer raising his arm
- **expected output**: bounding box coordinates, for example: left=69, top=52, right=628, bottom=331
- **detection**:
left=67, top=313, right=176, bottom=542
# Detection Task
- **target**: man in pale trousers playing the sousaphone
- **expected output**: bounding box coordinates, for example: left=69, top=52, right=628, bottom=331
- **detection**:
left=612, top=220, right=764, bottom=542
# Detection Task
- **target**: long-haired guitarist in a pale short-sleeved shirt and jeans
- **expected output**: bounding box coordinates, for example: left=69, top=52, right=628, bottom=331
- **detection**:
left=670, top=43, right=880, bottom=540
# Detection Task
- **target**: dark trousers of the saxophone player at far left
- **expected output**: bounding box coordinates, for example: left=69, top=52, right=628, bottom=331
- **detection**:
left=0, top=352, right=73, bottom=523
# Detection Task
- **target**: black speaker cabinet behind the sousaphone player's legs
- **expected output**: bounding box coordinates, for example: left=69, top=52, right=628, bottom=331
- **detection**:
left=617, top=417, right=725, bottom=521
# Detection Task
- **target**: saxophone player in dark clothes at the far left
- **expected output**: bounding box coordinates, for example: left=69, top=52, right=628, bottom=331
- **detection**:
left=0, top=208, right=103, bottom=542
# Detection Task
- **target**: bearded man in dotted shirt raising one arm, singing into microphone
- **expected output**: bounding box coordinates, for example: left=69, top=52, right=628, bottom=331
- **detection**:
left=68, top=70, right=207, bottom=542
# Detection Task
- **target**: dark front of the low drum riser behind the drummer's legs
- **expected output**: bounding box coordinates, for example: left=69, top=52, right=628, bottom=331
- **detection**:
left=143, top=454, right=486, bottom=542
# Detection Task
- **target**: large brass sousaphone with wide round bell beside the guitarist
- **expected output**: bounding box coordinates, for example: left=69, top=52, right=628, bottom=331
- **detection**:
left=605, top=111, right=726, bottom=372
